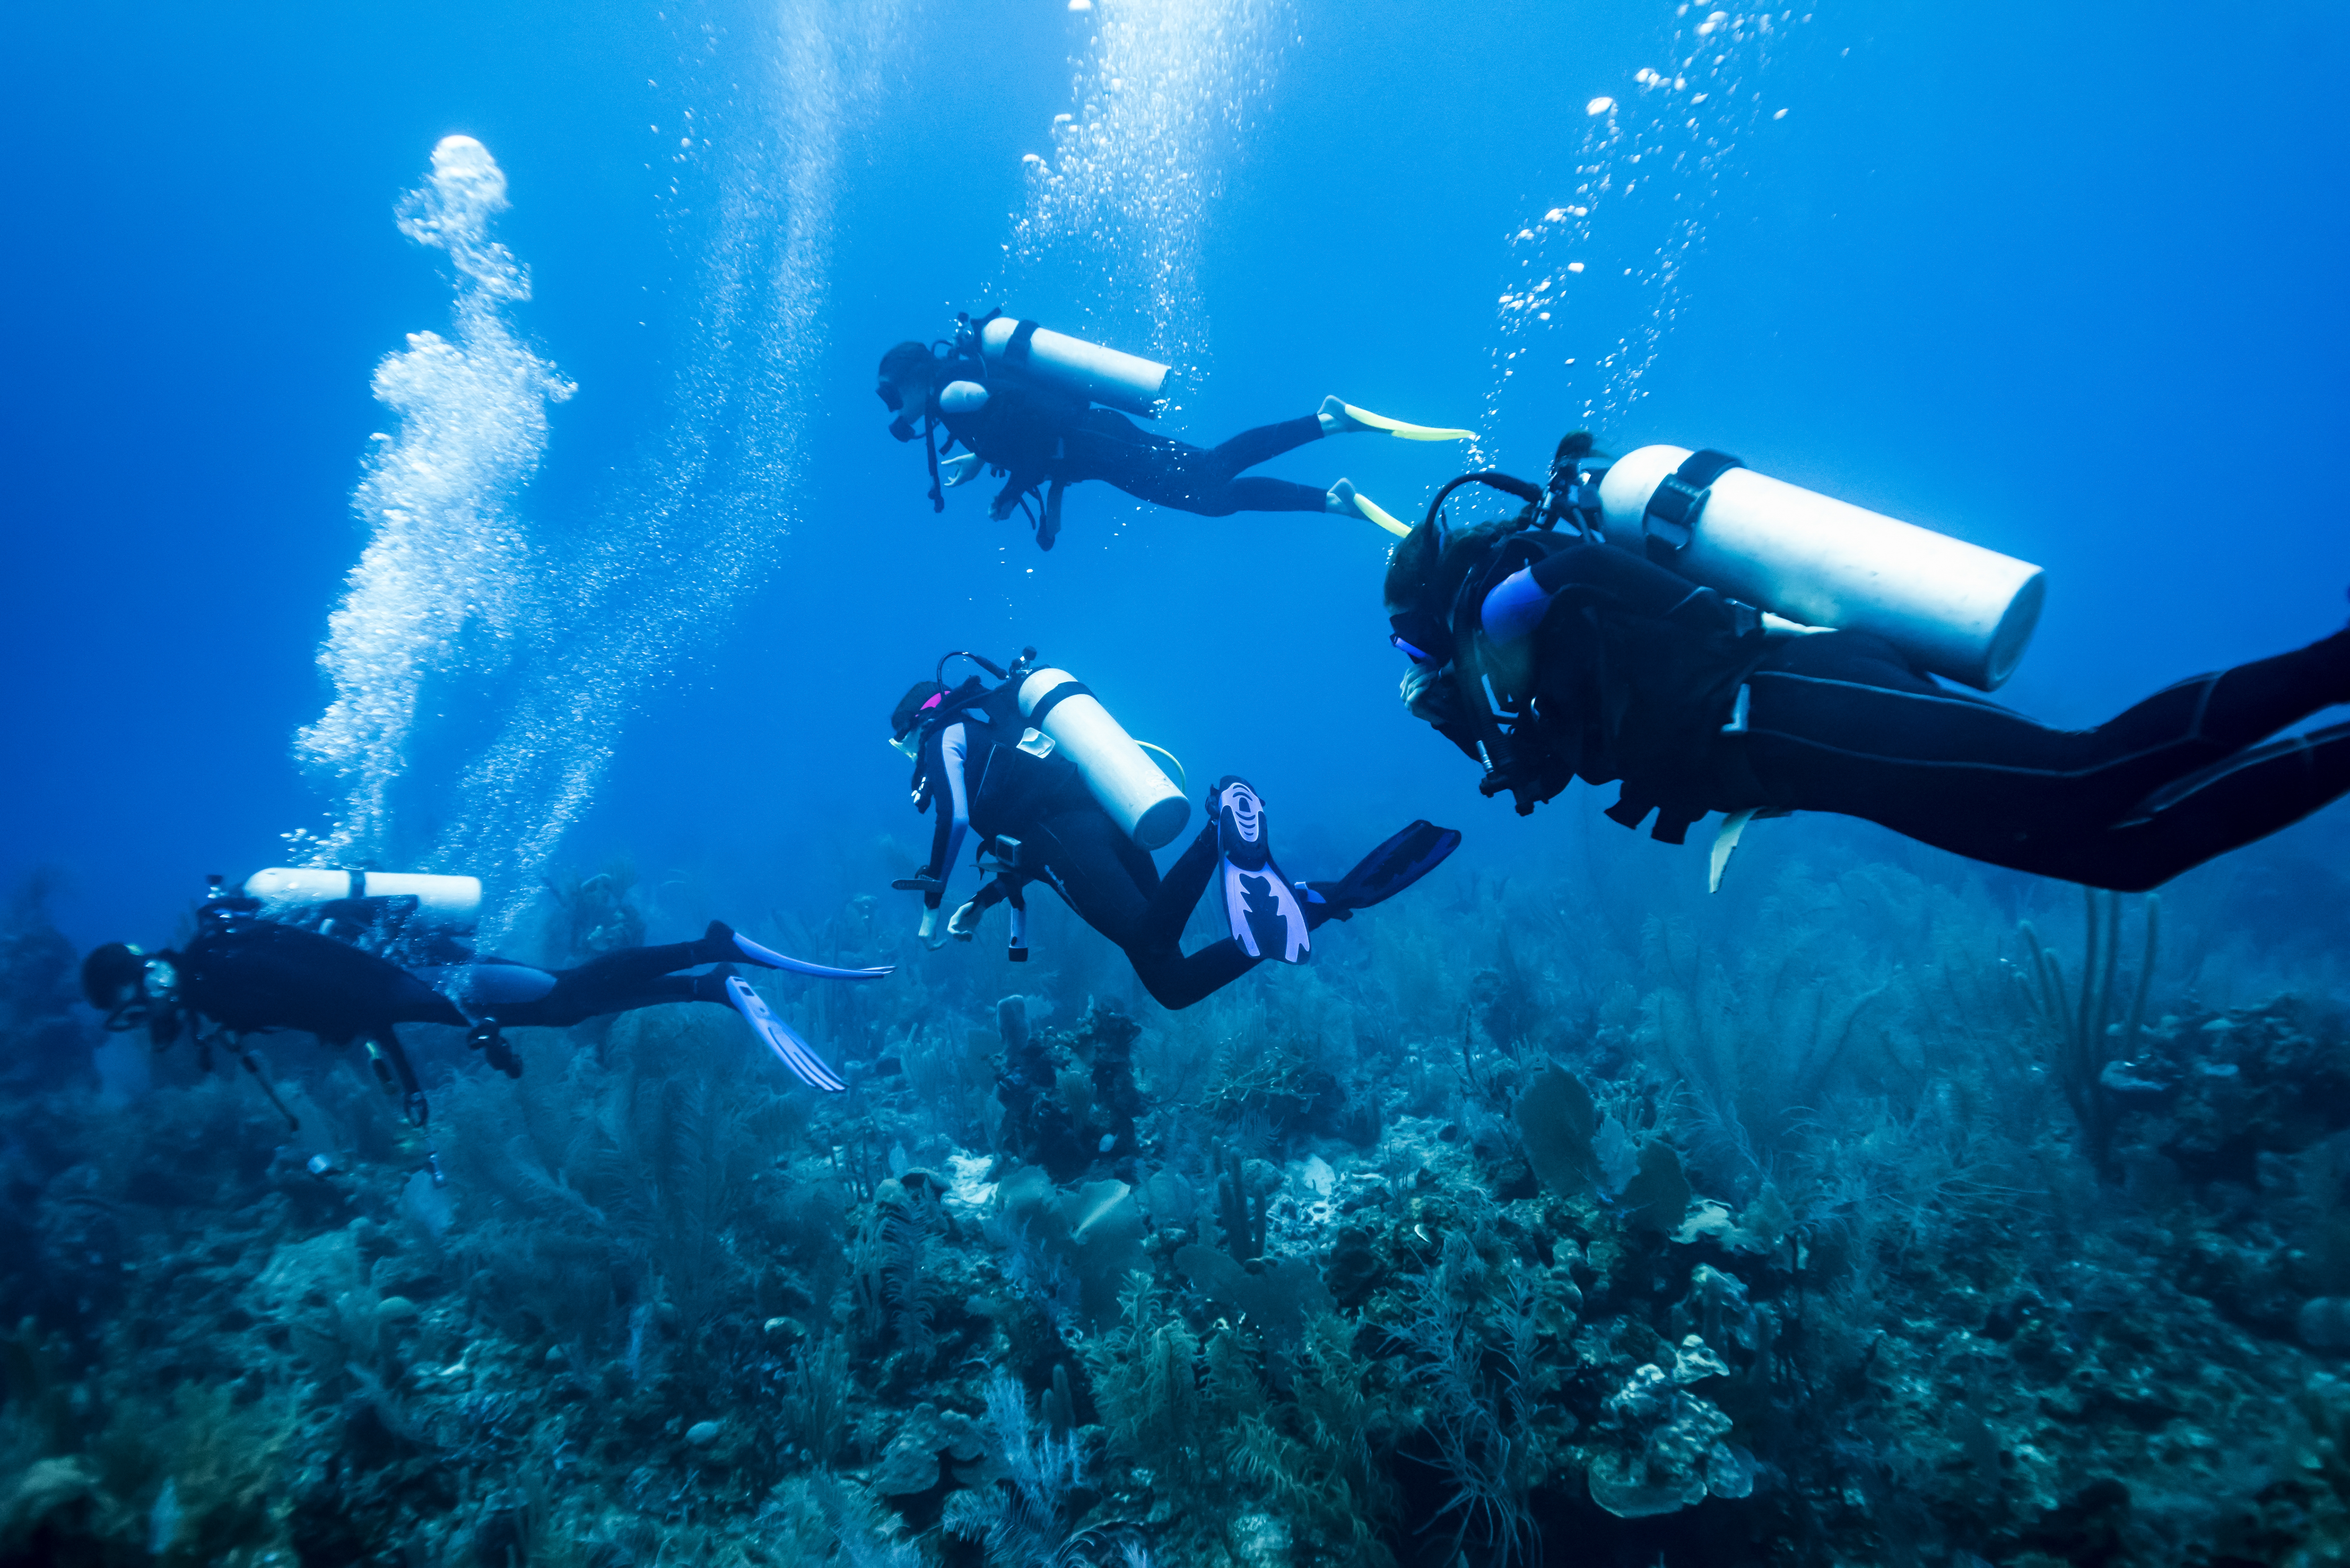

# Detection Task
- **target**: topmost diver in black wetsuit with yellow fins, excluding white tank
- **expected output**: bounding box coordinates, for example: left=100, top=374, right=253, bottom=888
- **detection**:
left=876, top=329, right=1469, bottom=550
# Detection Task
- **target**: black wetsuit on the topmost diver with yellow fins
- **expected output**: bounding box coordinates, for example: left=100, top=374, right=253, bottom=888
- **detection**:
left=938, top=381, right=1328, bottom=517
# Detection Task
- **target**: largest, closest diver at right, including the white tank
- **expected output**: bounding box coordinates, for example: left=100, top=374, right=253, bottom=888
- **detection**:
left=1387, top=433, right=2350, bottom=893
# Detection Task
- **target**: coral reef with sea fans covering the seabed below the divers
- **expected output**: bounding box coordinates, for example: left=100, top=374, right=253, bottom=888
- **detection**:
left=0, top=865, right=2350, bottom=1568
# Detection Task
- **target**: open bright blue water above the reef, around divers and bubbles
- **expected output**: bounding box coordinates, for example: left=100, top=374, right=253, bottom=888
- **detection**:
left=5, top=5, right=2350, bottom=940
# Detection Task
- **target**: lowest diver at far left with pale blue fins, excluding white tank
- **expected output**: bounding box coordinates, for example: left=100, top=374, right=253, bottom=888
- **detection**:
left=82, top=872, right=891, bottom=1147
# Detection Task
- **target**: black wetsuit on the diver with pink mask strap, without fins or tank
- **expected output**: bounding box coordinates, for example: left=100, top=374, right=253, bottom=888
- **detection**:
left=914, top=682, right=1321, bottom=1009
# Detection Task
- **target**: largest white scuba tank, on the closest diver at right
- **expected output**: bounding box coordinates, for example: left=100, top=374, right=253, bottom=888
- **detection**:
left=1600, top=447, right=2047, bottom=691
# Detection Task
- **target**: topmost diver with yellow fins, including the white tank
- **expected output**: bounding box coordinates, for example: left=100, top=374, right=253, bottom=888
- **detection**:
left=876, top=310, right=1474, bottom=550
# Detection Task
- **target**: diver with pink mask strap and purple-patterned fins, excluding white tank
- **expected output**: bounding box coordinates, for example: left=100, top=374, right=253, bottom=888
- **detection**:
left=891, top=656, right=1459, bottom=1009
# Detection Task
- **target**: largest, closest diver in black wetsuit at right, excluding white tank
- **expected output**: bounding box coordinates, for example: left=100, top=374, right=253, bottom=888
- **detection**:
left=1387, top=435, right=2350, bottom=893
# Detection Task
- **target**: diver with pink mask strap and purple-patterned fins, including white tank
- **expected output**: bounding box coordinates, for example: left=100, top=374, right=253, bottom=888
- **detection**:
left=891, top=649, right=1459, bottom=1011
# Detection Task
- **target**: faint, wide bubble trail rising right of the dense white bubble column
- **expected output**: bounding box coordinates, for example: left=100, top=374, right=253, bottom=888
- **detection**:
left=432, top=0, right=905, bottom=940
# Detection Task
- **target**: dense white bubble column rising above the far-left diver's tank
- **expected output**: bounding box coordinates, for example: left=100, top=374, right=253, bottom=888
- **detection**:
left=289, top=137, right=573, bottom=865
